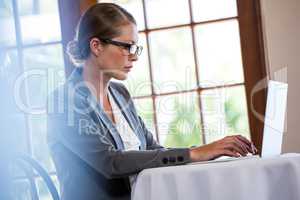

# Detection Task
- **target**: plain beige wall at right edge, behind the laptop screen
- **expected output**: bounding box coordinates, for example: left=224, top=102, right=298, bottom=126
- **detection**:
left=261, top=0, right=300, bottom=153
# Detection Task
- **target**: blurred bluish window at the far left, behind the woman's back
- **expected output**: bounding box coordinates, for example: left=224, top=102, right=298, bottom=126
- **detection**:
left=0, top=0, right=65, bottom=199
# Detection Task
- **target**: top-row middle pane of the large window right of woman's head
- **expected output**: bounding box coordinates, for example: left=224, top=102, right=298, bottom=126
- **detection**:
left=145, top=0, right=191, bottom=28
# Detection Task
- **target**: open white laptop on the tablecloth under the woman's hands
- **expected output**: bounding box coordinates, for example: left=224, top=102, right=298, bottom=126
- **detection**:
left=190, top=80, right=288, bottom=163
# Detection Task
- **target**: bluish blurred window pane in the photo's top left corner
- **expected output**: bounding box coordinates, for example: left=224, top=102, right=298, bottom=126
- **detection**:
left=0, top=0, right=16, bottom=48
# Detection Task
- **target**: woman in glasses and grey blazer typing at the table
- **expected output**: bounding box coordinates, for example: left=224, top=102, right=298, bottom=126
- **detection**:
left=48, top=3, right=255, bottom=200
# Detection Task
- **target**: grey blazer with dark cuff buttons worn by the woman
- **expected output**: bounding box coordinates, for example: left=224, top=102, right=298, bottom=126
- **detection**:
left=47, top=68, right=190, bottom=200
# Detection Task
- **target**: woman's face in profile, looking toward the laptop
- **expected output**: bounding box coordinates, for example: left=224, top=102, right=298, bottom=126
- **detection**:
left=97, top=23, right=138, bottom=80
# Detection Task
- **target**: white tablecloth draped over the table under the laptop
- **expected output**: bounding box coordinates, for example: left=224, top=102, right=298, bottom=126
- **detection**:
left=132, top=154, right=300, bottom=200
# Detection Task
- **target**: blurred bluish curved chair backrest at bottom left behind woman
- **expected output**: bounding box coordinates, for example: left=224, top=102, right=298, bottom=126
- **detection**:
left=14, top=154, right=60, bottom=200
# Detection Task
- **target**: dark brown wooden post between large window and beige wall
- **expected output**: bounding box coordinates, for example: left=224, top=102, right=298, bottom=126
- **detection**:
left=237, top=0, right=267, bottom=153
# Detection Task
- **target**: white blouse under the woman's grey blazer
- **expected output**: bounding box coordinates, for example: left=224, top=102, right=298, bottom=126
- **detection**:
left=108, top=91, right=141, bottom=188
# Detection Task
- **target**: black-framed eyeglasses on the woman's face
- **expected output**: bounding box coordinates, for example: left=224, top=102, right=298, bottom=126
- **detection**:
left=98, top=38, right=143, bottom=56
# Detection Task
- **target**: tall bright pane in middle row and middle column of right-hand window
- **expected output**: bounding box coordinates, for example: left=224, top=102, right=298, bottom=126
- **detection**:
left=150, top=28, right=196, bottom=93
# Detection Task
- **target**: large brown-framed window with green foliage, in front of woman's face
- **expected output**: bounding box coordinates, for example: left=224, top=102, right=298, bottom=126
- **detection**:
left=99, top=0, right=259, bottom=147
